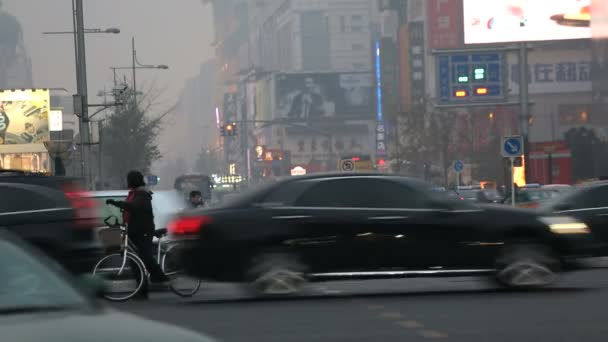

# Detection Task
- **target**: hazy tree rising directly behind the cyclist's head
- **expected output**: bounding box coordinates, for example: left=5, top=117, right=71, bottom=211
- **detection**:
left=102, top=93, right=172, bottom=187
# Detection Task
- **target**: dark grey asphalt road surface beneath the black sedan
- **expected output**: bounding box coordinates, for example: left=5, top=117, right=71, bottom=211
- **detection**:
left=115, top=269, right=608, bottom=342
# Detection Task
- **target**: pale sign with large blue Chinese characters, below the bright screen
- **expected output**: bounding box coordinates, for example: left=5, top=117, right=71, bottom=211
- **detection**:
left=509, top=50, right=591, bottom=94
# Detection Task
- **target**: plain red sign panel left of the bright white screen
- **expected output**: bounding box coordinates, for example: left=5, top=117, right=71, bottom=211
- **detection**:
left=427, top=0, right=464, bottom=49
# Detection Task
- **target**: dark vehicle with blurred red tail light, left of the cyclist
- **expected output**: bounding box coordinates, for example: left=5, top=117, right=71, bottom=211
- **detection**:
left=0, top=170, right=102, bottom=273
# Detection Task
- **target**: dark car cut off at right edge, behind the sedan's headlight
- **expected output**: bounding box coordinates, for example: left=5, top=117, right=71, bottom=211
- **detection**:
left=539, top=181, right=608, bottom=251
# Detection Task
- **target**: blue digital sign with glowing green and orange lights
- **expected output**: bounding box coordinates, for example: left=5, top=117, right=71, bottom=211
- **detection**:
left=437, top=52, right=506, bottom=104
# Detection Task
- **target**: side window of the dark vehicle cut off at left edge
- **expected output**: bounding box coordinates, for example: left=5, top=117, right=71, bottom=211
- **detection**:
left=0, top=186, right=56, bottom=213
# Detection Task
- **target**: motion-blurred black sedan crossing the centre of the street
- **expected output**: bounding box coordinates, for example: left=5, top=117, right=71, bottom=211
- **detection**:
left=169, top=174, right=597, bottom=294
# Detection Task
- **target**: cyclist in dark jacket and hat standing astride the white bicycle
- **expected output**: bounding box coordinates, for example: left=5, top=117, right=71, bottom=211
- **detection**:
left=107, top=171, right=169, bottom=297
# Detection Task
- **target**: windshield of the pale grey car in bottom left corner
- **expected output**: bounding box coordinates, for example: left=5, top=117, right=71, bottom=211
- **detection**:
left=0, top=237, right=88, bottom=315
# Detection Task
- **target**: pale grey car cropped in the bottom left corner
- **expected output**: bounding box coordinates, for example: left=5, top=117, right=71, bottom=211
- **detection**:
left=0, top=230, right=217, bottom=342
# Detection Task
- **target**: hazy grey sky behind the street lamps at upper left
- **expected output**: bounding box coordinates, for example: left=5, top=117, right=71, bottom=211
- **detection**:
left=3, top=0, right=213, bottom=106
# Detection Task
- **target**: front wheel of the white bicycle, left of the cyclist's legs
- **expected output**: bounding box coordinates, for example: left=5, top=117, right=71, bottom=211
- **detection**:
left=93, top=253, right=146, bottom=302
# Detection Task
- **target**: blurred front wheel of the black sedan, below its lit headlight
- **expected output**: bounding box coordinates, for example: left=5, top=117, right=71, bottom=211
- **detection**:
left=496, top=244, right=559, bottom=289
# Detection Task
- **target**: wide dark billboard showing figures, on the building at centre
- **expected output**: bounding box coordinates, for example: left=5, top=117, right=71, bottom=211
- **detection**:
left=275, top=73, right=375, bottom=121
